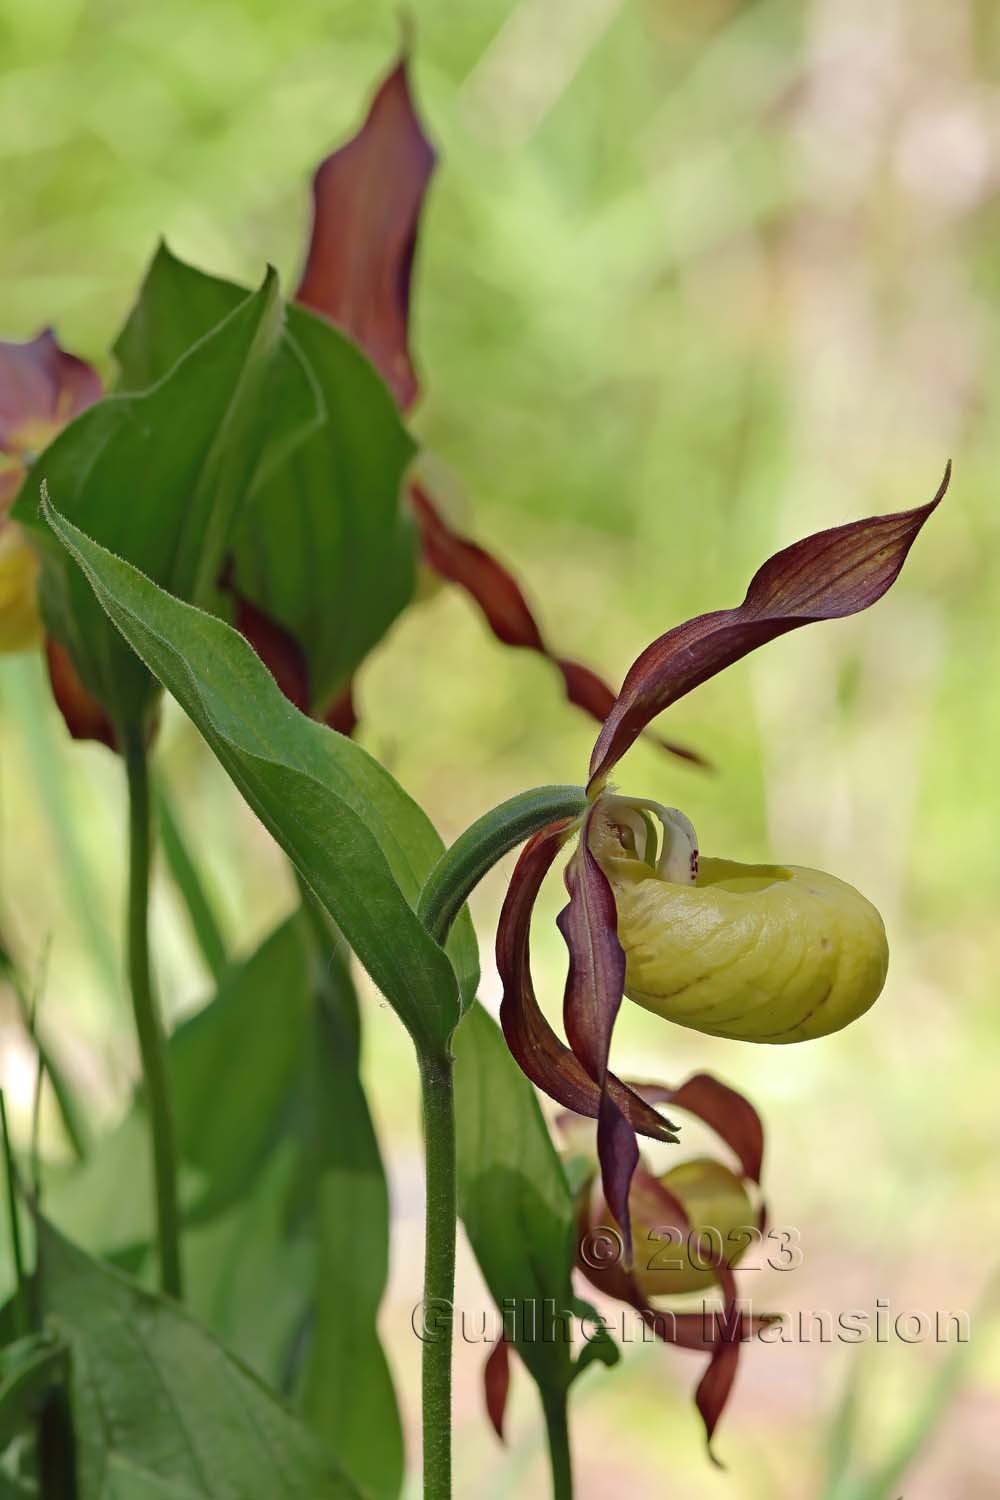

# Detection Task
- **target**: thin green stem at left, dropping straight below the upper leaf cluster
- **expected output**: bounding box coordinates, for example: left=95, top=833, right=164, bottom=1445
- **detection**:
left=123, top=732, right=181, bottom=1298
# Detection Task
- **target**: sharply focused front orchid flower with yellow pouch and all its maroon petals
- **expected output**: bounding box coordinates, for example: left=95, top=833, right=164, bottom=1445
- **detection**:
left=496, top=468, right=951, bottom=1266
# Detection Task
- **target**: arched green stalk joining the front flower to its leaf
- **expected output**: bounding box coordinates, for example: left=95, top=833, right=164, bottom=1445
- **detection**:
left=417, top=786, right=588, bottom=942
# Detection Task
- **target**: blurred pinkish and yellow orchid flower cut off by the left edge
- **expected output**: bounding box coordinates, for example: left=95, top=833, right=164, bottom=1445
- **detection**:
left=0, top=337, right=100, bottom=653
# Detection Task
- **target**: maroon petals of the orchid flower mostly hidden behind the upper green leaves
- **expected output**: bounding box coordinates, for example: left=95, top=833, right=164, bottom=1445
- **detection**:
left=234, top=59, right=702, bottom=764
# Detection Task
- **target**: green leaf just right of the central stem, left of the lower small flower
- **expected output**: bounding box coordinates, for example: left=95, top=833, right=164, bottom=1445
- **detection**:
left=454, top=1005, right=576, bottom=1392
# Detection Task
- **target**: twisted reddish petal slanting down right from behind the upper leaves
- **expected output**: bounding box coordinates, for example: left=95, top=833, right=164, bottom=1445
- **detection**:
left=409, top=485, right=708, bottom=765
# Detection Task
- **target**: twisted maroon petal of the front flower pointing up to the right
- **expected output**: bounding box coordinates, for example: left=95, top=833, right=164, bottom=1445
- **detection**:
left=591, top=464, right=951, bottom=783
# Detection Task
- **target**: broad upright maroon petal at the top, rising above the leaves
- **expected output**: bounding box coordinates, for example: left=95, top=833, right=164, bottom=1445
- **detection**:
left=295, top=60, right=435, bottom=411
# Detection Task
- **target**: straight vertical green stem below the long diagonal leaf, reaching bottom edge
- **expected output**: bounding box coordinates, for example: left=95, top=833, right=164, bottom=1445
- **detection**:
left=420, top=1055, right=457, bottom=1500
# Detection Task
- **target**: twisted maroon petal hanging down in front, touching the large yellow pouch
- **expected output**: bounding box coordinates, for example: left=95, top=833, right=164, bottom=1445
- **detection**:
left=558, top=807, right=639, bottom=1265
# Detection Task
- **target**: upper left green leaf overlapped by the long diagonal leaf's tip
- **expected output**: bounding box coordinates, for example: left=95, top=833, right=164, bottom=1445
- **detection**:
left=15, top=272, right=289, bottom=726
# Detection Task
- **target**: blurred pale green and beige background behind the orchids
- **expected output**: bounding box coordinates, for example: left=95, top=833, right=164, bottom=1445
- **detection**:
left=0, top=0, right=1000, bottom=1500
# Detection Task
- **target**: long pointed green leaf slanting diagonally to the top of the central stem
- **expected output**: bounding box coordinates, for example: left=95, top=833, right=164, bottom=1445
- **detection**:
left=45, top=504, right=475, bottom=1049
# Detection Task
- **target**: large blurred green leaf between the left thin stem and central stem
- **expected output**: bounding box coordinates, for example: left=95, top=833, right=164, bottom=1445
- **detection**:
left=171, top=914, right=403, bottom=1500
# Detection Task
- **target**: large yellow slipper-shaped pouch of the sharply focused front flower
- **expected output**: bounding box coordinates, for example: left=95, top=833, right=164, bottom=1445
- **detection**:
left=591, top=797, right=889, bottom=1043
